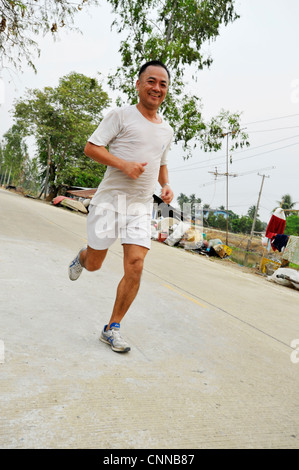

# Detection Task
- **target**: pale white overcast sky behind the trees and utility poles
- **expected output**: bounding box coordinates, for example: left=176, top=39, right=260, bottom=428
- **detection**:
left=0, top=0, right=299, bottom=222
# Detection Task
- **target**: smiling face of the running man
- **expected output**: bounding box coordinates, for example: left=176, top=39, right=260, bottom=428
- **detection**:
left=136, top=65, right=169, bottom=110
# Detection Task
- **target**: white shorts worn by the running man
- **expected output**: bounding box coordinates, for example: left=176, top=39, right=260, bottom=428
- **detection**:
left=87, top=205, right=151, bottom=250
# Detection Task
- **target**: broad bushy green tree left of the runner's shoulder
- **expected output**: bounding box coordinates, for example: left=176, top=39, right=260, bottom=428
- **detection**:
left=14, top=72, right=110, bottom=199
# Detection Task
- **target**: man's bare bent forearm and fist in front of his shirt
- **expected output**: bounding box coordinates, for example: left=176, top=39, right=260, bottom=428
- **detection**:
left=84, top=142, right=147, bottom=179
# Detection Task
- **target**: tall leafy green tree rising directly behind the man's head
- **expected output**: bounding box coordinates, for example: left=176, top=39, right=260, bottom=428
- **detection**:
left=108, top=0, right=249, bottom=157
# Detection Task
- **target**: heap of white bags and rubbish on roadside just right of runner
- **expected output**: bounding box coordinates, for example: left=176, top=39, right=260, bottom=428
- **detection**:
left=151, top=217, right=232, bottom=258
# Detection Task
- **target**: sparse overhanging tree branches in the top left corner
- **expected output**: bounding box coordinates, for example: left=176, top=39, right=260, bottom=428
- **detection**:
left=0, top=0, right=97, bottom=70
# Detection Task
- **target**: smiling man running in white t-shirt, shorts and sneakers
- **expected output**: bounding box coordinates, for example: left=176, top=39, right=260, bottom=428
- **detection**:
left=69, top=61, right=173, bottom=352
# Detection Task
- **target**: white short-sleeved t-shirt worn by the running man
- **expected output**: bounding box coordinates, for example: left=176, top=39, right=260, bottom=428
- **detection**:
left=88, top=105, right=173, bottom=214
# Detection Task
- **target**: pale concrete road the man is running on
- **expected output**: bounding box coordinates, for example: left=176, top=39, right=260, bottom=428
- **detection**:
left=0, top=190, right=299, bottom=449
